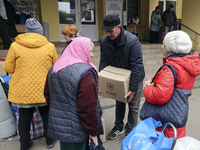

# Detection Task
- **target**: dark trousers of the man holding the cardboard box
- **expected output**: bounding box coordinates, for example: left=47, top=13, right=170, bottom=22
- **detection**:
left=115, top=81, right=143, bottom=134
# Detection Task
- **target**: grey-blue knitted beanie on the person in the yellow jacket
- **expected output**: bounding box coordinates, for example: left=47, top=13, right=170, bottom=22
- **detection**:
left=25, top=18, right=43, bottom=35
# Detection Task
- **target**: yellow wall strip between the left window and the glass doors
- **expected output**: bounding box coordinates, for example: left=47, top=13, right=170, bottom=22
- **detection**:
left=40, top=0, right=60, bottom=42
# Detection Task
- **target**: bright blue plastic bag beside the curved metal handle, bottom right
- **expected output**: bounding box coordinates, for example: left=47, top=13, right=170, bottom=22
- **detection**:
left=121, top=118, right=174, bottom=150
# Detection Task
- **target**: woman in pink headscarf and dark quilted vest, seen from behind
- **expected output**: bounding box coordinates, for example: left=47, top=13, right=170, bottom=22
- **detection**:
left=44, top=37, right=103, bottom=150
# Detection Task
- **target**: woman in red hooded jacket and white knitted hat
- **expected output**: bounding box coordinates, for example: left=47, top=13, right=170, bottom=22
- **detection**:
left=144, top=31, right=200, bottom=138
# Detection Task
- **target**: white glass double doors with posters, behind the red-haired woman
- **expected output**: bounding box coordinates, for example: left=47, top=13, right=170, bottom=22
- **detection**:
left=58, top=0, right=99, bottom=42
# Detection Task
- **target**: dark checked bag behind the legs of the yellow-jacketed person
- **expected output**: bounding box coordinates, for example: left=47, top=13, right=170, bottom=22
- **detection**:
left=15, top=108, right=44, bottom=139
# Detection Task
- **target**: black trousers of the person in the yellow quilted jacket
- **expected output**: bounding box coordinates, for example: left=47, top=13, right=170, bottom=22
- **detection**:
left=18, top=105, right=54, bottom=150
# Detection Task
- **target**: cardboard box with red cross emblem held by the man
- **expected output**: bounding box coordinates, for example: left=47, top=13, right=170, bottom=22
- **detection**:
left=98, top=66, right=131, bottom=103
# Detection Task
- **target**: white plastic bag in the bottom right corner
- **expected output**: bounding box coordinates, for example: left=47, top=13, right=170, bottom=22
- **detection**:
left=174, top=136, right=200, bottom=150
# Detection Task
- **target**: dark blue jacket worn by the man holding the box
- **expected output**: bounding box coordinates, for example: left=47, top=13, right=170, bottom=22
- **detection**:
left=99, top=28, right=145, bottom=91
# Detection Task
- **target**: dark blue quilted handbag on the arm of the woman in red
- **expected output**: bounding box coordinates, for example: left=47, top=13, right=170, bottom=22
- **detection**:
left=140, top=64, right=192, bottom=128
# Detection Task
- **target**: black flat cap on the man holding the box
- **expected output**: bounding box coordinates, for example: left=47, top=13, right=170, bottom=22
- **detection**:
left=101, top=15, right=120, bottom=31
